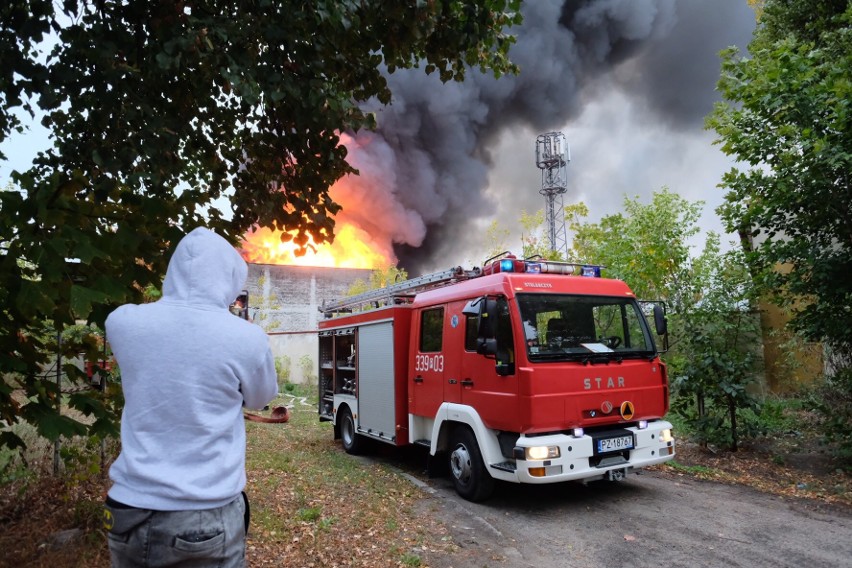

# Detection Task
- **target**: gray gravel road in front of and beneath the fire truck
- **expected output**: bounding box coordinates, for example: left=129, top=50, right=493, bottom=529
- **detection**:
left=408, top=471, right=852, bottom=568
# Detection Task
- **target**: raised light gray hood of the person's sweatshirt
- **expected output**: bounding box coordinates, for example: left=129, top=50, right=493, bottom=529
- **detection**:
left=162, top=227, right=248, bottom=309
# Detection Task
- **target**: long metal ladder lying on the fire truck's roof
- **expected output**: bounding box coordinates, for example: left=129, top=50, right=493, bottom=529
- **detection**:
left=319, top=266, right=482, bottom=317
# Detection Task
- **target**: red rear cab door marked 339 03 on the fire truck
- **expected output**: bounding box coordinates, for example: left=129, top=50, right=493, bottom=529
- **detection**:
left=409, top=306, right=446, bottom=418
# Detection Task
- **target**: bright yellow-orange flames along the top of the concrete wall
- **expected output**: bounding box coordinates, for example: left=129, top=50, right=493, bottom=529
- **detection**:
left=240, top=223, right=395, bottom=269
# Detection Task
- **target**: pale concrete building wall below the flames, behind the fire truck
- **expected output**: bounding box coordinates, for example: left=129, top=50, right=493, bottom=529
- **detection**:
left=246, top=264, right=371, bottom=384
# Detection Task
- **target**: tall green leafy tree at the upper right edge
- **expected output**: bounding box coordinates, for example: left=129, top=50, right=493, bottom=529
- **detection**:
left=708, top=0, right=852, bottom=353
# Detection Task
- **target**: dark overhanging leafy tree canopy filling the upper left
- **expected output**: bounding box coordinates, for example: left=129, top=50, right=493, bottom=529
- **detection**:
left=0, top=0, right=520, bottom=452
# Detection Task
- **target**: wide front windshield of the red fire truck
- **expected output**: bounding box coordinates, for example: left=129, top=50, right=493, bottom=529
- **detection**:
left=517, top=294, right=656, bottom=360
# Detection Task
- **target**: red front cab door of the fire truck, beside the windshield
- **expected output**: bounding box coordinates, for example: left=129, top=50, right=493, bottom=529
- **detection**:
left=459, top=298, right=518, bottom=431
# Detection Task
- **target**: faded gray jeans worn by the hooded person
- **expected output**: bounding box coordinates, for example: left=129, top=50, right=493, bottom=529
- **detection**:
left=104, top=495, right=246, bottom=568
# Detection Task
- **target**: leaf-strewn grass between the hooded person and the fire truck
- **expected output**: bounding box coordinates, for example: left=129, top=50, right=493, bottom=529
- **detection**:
left=246, top=386, right=451, bottom=566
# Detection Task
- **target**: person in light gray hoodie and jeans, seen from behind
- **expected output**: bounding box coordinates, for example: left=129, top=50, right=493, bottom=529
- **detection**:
left=104, top=228, right=278, bottom=567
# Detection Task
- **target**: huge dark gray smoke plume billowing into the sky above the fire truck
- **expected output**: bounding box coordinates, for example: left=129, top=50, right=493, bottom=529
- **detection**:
left=335, top=0, right=755, bottom=274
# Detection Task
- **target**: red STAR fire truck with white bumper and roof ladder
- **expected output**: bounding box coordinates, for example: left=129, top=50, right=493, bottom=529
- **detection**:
left=319, top=253, right=674, bottom=501
